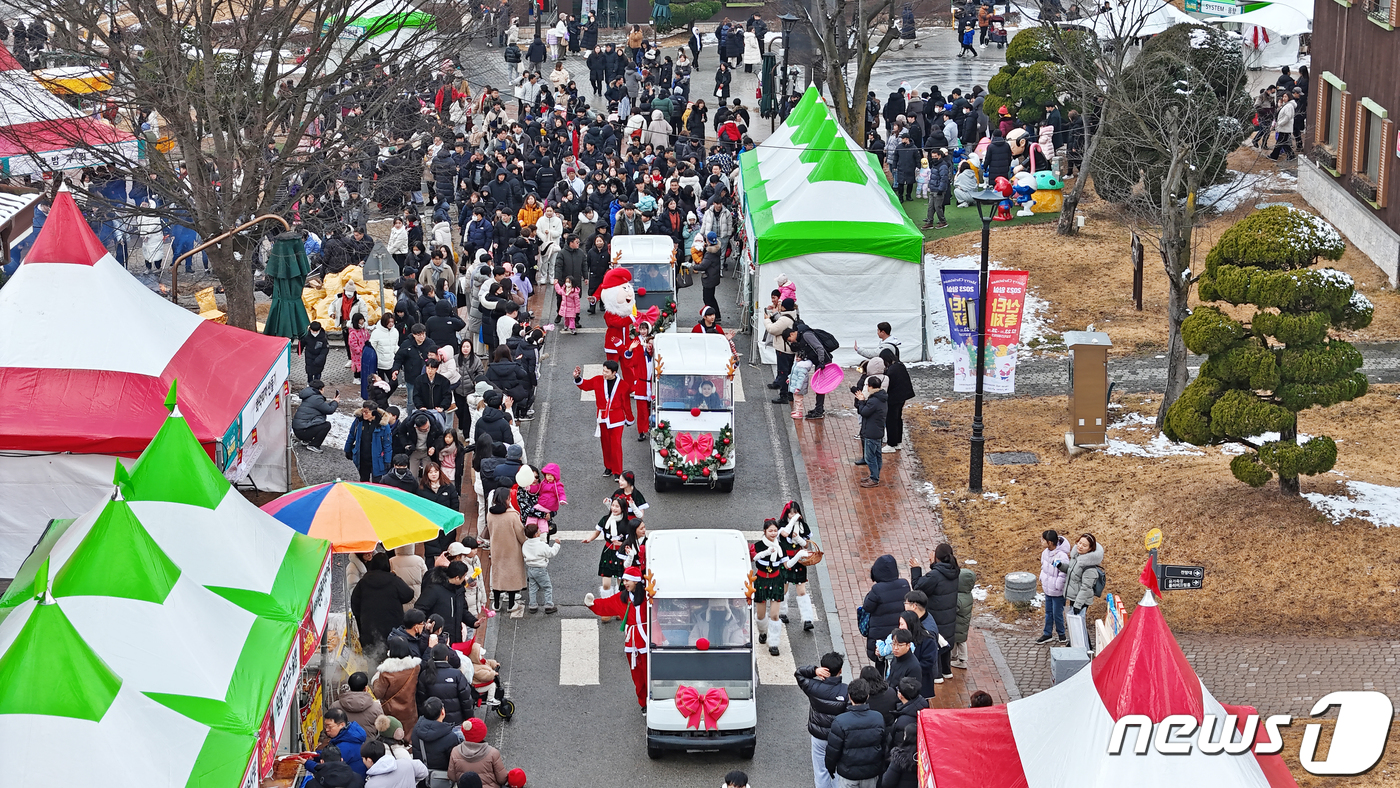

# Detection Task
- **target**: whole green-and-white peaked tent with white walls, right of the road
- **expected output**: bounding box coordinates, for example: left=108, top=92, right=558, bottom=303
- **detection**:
left=739, top=88, right=924, bottom=364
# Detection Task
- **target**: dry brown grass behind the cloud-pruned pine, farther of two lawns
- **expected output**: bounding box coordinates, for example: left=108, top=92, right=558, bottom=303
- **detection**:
left=925, top=151, right=1400, bottom=356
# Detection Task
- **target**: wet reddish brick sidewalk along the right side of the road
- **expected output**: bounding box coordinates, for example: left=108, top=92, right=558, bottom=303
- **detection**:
left=795, top=371, right=1009, bottom=708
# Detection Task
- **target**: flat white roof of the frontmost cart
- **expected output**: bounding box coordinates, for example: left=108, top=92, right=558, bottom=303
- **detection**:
left=647, top=528, right=752, bottom=599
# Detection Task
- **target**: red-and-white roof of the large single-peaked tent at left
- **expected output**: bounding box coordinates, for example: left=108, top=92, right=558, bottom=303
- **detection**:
left=0, top=189, right=288, bottom=456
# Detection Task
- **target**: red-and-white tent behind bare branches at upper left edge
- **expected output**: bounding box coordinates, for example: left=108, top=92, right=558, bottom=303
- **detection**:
left=0, top=45, right=136, bottom=176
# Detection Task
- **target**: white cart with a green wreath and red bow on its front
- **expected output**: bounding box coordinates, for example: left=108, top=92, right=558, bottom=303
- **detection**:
left=651, top=333, right=739, bottom=493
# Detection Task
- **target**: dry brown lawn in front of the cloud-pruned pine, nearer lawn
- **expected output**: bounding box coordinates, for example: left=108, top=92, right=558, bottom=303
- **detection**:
left=906, top=386, right=1400, bottom=637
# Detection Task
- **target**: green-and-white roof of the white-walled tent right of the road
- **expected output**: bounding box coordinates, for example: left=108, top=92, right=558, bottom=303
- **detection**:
left=741, top=88, right=924, bottom=266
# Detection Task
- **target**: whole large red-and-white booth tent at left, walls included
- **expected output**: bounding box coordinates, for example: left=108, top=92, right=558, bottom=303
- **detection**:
left=0, top=189, right=290, bottom=577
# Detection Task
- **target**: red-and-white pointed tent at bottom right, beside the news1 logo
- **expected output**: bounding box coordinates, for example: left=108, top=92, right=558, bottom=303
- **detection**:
left=918, top=592, right=1298, bottom=788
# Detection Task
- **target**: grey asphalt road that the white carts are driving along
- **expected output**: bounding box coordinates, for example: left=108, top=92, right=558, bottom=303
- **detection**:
left=284, top=271, right=832, bottom=788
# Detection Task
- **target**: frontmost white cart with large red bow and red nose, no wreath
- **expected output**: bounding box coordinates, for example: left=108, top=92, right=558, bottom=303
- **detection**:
left=647, top=529, right=759, bottom=759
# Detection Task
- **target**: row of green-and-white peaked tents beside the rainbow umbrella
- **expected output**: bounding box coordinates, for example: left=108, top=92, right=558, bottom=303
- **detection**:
left=0, top=391, right=330, bottom=788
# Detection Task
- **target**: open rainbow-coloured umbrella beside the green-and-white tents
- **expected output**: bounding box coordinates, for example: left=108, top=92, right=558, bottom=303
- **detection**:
left=262, top=481, right=462, bottom=553
